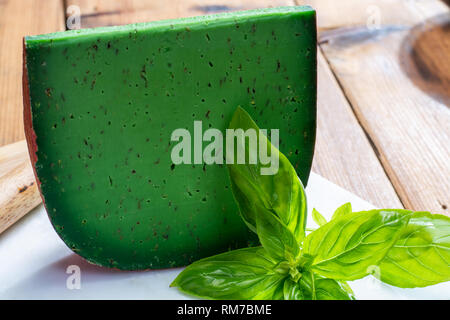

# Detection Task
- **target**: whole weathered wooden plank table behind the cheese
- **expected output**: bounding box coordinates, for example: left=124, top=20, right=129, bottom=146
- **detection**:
left=0, top=0, right=450, bottom=232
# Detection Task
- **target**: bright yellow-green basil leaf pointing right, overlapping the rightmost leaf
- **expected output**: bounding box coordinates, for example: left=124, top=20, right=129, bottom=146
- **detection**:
left=303, top=210, right=411, bottom=280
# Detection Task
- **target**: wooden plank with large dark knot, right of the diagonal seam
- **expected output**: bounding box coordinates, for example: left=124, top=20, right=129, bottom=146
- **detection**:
left=298, top=0, right=450, bottom=214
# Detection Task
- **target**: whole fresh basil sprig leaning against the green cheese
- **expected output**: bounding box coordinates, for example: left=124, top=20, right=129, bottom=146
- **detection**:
left=171, top=108, right=450, bottom=300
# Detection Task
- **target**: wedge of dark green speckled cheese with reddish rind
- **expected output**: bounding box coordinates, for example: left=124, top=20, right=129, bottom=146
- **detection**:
left=24, top=7, right=316, bottom=270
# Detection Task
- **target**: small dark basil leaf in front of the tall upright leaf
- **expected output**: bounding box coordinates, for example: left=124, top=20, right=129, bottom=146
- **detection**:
left=256, top=208, right=300, bottom=263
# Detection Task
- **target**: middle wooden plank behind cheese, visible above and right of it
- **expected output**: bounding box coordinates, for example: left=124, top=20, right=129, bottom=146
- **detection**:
left=67, top=0, right=402, bottom=208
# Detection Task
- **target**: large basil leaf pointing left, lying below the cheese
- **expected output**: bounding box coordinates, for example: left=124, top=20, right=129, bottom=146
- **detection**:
left=171, top=247, right=286, bottom=300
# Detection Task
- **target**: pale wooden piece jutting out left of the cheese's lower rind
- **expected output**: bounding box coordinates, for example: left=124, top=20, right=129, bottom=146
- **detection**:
left=0, top=141, right=41, bottom=233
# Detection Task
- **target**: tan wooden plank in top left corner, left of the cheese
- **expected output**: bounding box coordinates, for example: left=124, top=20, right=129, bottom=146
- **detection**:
left=0, top=0, right=64, bottom=146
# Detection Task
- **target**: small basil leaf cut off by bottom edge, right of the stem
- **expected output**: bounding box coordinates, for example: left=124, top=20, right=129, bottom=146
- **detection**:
left=296, top=271, right=354, bottom=300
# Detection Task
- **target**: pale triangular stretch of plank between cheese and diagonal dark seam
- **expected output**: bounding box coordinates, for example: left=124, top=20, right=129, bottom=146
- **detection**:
left=313, top=52, right=403, bottom=208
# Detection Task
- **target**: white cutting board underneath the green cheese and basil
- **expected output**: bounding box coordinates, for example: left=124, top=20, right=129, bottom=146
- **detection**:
left=0, top=173, right=450, bottom=300
